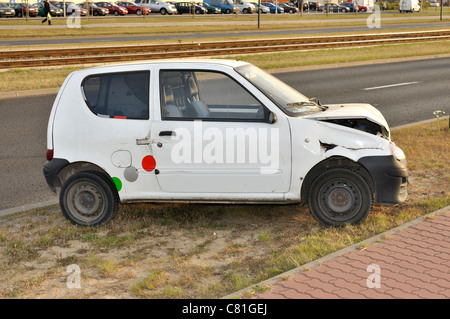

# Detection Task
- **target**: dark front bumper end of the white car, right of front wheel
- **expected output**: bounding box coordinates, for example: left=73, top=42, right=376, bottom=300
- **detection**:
left=358, top=156, right=408, bottom=205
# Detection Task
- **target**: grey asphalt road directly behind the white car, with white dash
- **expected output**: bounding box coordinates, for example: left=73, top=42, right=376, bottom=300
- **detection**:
left=0, top=58, right=450, bottom=210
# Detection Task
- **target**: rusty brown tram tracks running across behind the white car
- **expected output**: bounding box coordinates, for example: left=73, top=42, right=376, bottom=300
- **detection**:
left=0, top=30, right=450, bottom=69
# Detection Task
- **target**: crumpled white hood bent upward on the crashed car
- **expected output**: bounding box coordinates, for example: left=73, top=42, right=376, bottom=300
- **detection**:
left=305, top=103, right=389, bottom=130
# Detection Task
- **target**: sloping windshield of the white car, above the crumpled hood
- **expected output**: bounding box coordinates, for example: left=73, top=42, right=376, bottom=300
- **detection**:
left=236, top=64, right=324, bottom=116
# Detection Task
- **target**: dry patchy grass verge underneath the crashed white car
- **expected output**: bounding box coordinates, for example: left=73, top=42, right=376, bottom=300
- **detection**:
left=0, top=119, right=450, bottom=298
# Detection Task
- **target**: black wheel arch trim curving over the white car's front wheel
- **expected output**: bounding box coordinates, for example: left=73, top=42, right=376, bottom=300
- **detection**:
left=300, top=156, right=375, bottom=204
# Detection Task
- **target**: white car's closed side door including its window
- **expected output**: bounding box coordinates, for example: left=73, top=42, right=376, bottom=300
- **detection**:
left=151, top=69, right=291, bottom=197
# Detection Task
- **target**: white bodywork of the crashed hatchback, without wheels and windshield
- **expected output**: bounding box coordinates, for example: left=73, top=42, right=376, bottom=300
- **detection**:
left=44, top=59, right=406, bottom=212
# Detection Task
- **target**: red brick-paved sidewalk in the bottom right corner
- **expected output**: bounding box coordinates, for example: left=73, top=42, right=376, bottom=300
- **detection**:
left=255, top=211, right=450, bottom=299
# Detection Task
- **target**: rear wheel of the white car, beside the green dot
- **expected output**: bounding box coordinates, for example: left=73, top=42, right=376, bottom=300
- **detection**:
left=59, top=171, right=119, bottom=226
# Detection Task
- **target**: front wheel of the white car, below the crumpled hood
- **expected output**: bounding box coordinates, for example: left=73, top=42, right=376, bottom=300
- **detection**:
left=308, top=168, right=373, bottom=227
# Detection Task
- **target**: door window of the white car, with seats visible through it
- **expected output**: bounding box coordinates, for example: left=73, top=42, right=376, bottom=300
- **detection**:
left=160, top=70, right=266, bottom=122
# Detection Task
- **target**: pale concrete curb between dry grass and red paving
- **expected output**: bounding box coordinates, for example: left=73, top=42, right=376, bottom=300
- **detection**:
left=221, top=205, right=450, bottom=299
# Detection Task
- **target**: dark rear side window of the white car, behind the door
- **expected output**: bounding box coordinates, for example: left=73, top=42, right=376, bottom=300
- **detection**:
left=81, top=71, right=150, bottom=119
